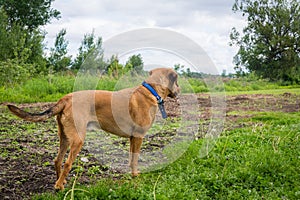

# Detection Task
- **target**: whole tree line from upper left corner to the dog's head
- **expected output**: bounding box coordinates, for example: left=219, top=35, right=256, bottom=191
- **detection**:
left=0, top=0, right=143, bottom=85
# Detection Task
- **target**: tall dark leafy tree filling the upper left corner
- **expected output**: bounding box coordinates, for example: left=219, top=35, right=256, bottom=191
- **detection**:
left=0, top=0, right=60, bottom=74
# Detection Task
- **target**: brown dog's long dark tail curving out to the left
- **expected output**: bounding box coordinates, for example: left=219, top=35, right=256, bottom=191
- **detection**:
left=7, top=101, right=65, bottom=122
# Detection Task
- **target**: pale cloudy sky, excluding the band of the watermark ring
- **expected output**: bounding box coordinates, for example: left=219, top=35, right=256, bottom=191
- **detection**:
left=45, top=0, right=246, bottom=74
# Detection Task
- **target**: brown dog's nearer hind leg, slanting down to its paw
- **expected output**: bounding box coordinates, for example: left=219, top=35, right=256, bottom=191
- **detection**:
left=55, top=127, right=83, bottom=190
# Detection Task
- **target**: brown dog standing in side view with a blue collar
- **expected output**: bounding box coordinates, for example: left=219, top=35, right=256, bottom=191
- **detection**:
left=8, top=68, right=180, bottom=190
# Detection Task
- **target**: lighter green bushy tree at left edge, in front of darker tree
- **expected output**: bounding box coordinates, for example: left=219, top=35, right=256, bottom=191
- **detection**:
left=0, top=8, right=46, bottom=85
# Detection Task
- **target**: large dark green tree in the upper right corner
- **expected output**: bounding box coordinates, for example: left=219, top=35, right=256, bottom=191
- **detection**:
left=230, top=0, right=300, bottom=83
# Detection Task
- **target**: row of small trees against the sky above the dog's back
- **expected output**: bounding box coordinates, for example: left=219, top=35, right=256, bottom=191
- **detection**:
left=48, top=29, right=144, bottom=78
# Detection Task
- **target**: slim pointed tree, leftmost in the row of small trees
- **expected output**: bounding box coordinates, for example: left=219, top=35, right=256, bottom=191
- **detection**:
left=48, top=29, right=72, bottom=72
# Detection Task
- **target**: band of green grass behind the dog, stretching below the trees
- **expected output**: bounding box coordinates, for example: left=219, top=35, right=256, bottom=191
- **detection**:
left=0, top=75, right=300, bottom=103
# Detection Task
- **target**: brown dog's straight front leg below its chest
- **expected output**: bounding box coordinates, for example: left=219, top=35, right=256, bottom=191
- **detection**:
left=129, top=137, right=143, bottom=176
